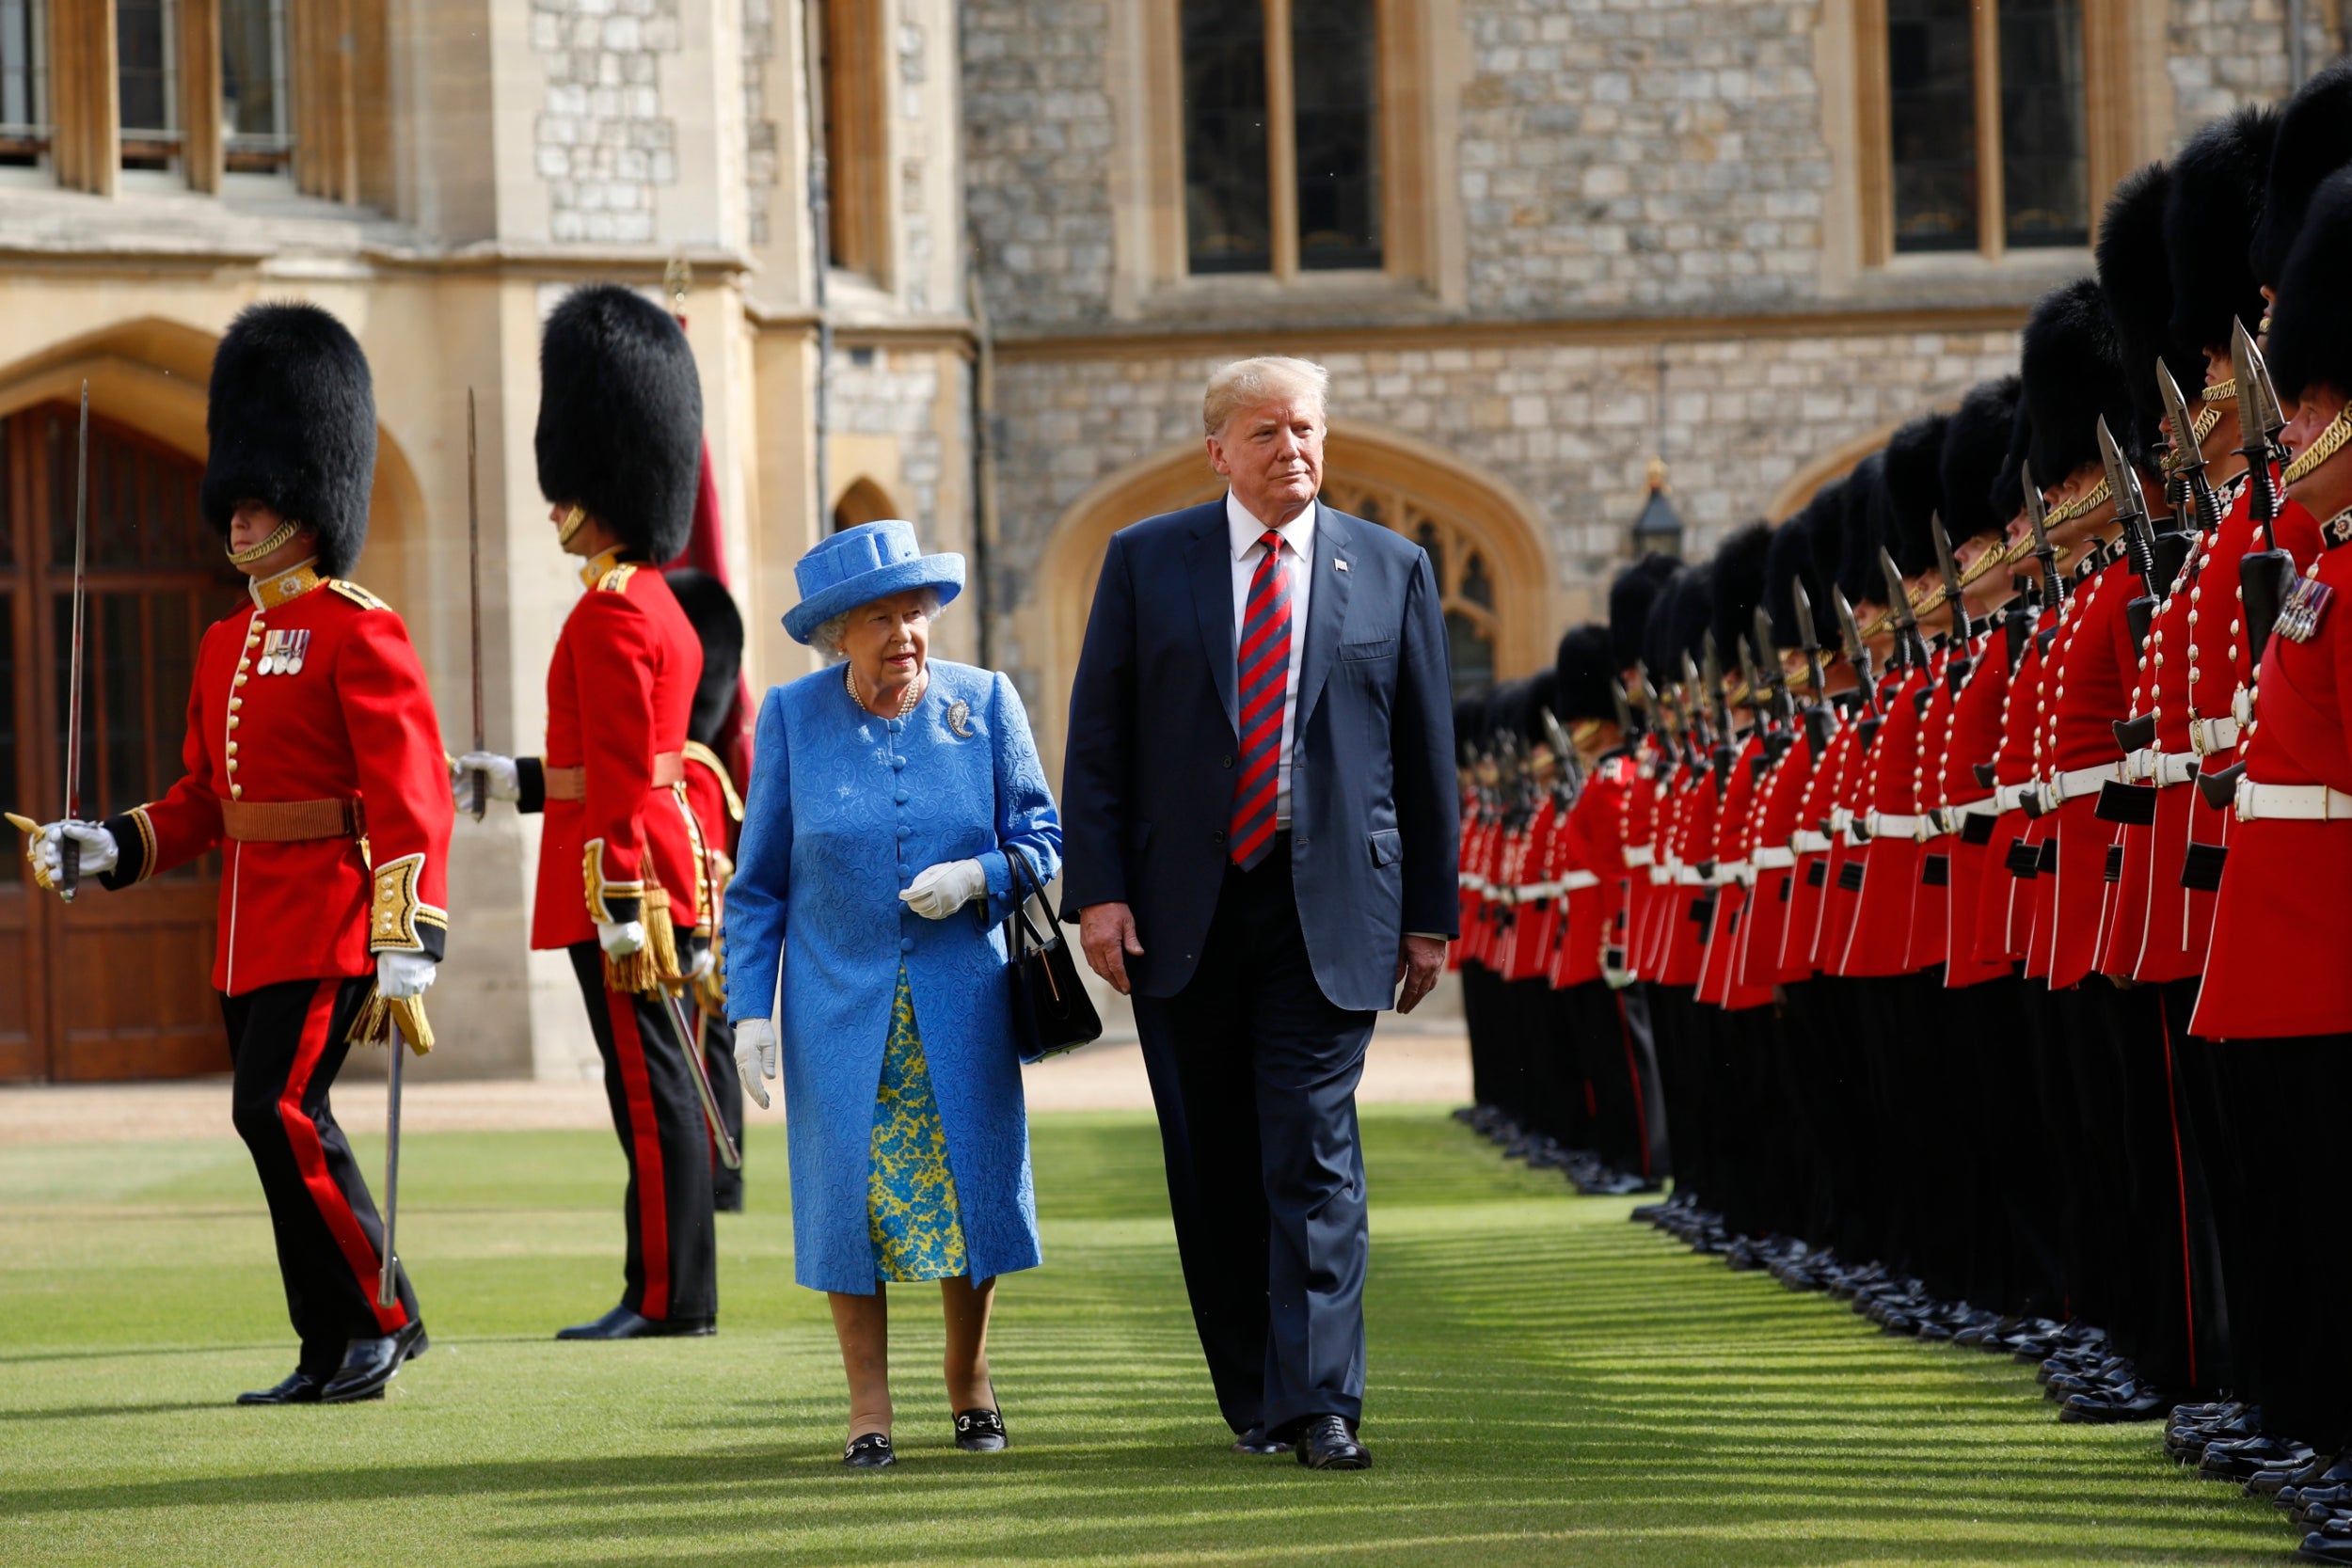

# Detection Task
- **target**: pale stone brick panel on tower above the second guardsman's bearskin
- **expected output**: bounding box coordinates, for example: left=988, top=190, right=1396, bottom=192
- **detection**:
left=532, top=0, right=680, bottom=245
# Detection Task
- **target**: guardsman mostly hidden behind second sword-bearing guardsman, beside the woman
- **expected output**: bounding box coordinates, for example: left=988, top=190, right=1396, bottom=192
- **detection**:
left=663, top=566, right=743, bottom=1213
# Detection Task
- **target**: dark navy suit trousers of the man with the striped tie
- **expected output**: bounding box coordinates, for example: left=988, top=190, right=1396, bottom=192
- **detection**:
left=1134, top=834, right=1374, bottom=1434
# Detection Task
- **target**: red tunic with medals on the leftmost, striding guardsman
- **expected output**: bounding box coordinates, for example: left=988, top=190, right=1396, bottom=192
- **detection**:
left=102, top=564, right=454, bottom=997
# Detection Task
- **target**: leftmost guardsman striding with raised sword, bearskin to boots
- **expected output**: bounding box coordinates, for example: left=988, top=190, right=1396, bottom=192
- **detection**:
left=13, top=303, right=452, bottom=1406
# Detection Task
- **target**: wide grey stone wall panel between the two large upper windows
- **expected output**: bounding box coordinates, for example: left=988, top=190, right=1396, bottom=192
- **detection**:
left=1461, top=0, right=1830, bottom=315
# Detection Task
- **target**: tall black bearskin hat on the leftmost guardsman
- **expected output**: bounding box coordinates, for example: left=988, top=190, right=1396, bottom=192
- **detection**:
left=198, top=303, right=376, bottom=576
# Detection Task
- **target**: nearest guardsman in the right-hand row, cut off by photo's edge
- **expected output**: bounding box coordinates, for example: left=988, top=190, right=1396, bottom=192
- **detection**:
left=2195, top=171, right=2352, bottom=1504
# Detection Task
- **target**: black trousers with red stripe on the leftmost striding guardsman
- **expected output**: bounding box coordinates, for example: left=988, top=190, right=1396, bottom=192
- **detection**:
left=221, top=975, right=417, bottom=1378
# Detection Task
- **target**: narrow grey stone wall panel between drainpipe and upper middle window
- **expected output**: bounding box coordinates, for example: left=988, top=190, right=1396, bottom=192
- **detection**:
left=962, top=0, right=1115, bottom=325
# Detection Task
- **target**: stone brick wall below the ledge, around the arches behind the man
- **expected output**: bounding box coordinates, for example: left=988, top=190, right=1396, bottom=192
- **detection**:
left=995, top=331, right=2016, bottom=703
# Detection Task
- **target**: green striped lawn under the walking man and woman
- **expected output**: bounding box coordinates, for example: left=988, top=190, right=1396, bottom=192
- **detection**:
left=0, top=1110, right=2291, bottom=1568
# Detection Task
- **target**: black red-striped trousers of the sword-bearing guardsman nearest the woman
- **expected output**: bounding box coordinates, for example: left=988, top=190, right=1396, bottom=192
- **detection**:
left=567, top=942, right=720, bottom=1322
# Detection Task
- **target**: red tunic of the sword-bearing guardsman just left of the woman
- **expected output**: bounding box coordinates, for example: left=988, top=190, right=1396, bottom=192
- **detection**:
left=522, top=555, right=704, bottom=947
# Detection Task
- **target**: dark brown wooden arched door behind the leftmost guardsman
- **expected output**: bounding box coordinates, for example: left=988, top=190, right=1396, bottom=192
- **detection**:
left=0, top=404, right=245, bottom=1082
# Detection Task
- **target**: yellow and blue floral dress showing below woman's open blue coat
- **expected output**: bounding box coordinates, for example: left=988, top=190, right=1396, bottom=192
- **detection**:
left=866, top=964, right=972, bottom=1284
